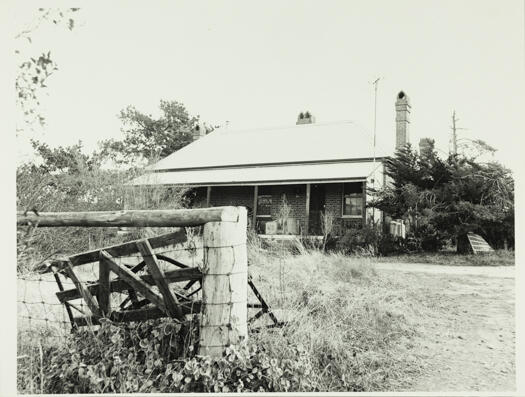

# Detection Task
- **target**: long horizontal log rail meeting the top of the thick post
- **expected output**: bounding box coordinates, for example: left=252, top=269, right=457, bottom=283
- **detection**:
left=16, top=207, right=239, bottom=227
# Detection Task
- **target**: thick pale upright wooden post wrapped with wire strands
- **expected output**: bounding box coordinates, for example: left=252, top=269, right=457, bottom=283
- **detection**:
left=199, top=207, right=248, bottom=357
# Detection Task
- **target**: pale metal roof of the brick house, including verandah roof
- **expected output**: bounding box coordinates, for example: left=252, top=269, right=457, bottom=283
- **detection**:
left=133, top=121, right=390, bottom=186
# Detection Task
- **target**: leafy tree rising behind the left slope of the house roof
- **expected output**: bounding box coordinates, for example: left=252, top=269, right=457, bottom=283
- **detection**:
left=101, top=100, right=212, bottom=164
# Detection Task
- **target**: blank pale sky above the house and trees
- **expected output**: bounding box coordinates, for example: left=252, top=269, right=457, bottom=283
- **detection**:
left=12, top=0, right=525, bottom=169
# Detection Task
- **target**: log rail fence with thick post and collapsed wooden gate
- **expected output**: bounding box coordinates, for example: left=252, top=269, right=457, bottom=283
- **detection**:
left=17, top=207, right=281, bottom=356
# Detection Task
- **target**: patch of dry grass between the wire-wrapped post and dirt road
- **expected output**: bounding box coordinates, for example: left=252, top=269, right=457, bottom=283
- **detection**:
left=250, top=246, right=421, bottom=391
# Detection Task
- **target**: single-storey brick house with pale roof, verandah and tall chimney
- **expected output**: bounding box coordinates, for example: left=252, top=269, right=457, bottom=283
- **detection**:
left=133, top=92, right=410, bottom=235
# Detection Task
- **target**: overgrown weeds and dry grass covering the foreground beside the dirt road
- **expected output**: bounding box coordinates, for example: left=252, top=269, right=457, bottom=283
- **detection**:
left=18, top=239, right=426, bottom=393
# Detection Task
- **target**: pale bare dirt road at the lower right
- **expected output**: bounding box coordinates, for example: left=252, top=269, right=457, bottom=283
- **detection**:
left=375, top=263, right=516, bottom=392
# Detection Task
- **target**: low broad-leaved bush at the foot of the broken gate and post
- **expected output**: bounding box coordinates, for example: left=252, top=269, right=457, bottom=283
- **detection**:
left=29, top=319, right=314, bottom=393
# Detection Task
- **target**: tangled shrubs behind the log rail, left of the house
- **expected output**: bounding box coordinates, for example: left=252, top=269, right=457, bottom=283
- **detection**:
left=16, top=141, right=187, bottom=271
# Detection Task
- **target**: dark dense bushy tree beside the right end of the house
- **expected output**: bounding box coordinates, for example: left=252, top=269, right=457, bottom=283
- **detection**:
left=371, top=141, right=514, bottom=251
